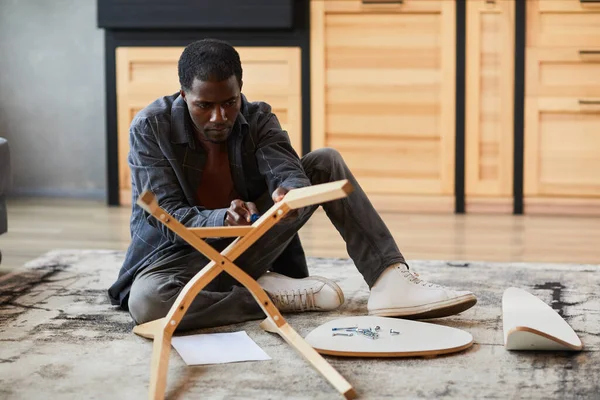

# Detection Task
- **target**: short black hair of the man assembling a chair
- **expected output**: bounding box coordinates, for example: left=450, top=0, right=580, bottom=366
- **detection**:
left=178, top=39, right=242, bottom=90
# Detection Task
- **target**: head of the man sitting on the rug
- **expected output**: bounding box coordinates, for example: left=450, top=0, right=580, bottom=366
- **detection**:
left=179, top=39, right=242, bottom=143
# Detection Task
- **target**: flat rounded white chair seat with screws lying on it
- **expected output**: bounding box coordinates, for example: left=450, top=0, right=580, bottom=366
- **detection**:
left=305, top=316, right=473, bottom=357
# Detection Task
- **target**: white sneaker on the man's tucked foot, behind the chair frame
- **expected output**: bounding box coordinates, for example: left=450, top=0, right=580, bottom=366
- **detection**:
left=257, top=272, right=344, bottom=312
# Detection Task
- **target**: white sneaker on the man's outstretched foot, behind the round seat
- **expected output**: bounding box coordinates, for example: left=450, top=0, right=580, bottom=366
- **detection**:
left=367, top=264, right=477, bottom=319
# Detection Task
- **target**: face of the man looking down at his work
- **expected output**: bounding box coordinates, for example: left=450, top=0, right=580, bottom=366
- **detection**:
left=181, top=75, right=242, bottom=143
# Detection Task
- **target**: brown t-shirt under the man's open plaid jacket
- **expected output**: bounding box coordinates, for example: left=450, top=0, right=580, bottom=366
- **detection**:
left=196, top=140, right=238, bottom=210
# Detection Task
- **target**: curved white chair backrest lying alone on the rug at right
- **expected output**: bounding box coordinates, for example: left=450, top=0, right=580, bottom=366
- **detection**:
left=502, top=287, right=583, bottom=351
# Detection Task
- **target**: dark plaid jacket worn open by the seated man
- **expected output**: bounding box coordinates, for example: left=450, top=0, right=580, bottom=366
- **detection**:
left=108, top=93, right=310, bottom=309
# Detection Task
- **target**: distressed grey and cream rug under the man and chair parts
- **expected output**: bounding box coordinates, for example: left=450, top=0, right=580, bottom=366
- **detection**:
left=0, top=250, right=600, bottom=399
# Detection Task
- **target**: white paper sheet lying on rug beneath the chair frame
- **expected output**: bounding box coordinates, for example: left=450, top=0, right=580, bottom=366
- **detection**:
left=171, top=331, right=271, bottom=365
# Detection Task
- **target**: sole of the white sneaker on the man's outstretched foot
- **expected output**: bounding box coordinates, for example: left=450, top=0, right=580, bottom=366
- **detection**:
left=369, top=294, right=477, bottom=319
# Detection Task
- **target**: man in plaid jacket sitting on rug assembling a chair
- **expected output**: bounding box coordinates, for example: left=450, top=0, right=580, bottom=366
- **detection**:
left=109, top=39, right=477, bottom=330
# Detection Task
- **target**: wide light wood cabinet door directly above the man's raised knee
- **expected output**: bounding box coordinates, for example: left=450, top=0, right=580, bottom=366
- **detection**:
left=311, top=0, right=456, bottom=212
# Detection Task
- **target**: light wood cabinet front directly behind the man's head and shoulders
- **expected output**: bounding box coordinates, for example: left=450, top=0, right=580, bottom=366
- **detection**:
left=116, top=47, right=302, bottom=204
